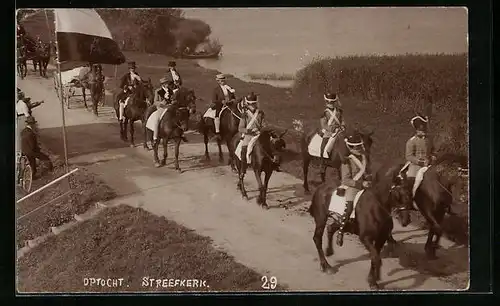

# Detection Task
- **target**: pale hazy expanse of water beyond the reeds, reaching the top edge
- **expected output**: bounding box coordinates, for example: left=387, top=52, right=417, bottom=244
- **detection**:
left=183, top=7, right=468, bottom=86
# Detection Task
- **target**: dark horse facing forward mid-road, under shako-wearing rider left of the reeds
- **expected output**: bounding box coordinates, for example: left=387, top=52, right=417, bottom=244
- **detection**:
left=229, top=129, right=287, bottom=209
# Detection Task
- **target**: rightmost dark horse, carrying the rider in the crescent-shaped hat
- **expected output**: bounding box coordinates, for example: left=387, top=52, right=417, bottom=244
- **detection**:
left=410, top=154, right=468, bottom=259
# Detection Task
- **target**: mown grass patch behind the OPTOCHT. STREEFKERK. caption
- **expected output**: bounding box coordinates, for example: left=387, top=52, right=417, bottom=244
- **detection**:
left=18, top=205, right=286, bottom=292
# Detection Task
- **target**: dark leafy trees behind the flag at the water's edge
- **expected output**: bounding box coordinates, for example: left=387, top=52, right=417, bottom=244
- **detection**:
left=18, top=8, right=212, bottom=55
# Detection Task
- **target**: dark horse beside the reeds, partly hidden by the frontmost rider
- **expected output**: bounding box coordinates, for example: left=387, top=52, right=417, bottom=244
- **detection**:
left=301, top=130, right=373, bottom=194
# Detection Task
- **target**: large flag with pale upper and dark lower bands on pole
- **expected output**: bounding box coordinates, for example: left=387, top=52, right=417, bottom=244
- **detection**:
left=54, top=9, right=125, bottom=65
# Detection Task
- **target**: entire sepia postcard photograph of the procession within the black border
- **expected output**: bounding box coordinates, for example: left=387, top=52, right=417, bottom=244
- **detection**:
left=14, top=7, right=470, bottom=294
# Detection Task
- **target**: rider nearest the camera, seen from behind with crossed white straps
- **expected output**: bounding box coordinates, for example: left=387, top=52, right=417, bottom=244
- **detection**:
left=337, top=132, right=370, bottom=246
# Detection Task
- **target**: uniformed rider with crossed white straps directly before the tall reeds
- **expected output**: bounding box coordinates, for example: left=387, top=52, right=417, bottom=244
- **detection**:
left=320, top=92, right=345, bottom=164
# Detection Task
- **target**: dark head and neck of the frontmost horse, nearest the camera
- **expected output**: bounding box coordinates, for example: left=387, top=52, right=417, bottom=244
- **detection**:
left=373, top=164, right=413, bottom=227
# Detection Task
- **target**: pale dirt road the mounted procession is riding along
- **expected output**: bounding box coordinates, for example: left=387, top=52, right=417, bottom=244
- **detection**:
left=18, top=72, right=469, bottom=291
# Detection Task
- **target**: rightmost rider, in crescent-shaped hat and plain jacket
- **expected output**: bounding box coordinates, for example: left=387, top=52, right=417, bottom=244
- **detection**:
left=402, top=115, right=436, bottom=188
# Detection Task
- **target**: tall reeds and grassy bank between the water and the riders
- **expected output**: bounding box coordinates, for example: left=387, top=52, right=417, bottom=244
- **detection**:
left=98, top=52, right=468, bottom=243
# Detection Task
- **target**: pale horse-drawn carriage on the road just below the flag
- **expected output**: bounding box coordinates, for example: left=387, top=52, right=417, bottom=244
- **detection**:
left=54, top=67, right=105, bottom=109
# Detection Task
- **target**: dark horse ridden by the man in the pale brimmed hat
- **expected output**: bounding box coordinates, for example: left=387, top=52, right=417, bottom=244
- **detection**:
left=198, top=98, right=244, bottom=171
